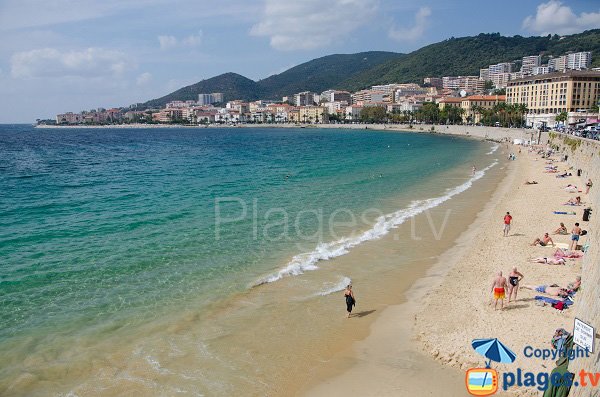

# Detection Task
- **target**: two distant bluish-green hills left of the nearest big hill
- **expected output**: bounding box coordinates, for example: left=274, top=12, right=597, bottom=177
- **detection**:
left=142, top=51, right=402, bottom=108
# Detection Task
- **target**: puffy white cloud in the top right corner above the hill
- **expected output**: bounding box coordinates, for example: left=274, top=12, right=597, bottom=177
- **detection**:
left=523, top=0, right=600, bottom=35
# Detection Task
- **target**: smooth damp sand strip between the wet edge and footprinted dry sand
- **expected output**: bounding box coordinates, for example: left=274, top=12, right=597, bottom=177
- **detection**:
left=302, top=138, right=519, bottom=397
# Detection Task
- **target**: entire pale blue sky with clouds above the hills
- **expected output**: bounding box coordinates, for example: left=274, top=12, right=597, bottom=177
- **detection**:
left=0, top=0, right=600, bottom=123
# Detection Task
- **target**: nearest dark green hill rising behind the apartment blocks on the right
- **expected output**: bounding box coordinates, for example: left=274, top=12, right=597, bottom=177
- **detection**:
left=336, top=29, right=600, bottom=91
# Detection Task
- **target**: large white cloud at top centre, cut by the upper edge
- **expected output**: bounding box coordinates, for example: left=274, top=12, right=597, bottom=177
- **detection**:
left=250, top=0, right=379, bottom=51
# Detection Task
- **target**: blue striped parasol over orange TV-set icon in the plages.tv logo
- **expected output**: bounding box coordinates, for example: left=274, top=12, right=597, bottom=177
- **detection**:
left=465, top=338, right=517, bottom=396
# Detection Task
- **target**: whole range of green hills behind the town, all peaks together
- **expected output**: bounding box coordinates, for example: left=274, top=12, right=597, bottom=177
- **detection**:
left=142, top=29, right=600, bottom=107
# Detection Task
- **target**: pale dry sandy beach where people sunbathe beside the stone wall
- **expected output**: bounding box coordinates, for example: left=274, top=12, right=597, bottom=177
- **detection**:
left=306, top=142, right=585, bottom=396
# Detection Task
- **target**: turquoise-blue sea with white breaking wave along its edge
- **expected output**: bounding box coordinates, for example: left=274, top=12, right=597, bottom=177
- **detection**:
left=0, top=125, right=493, bottom=395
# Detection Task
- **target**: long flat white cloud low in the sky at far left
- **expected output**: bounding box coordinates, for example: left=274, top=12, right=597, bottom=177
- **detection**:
left=10, top=48, right=135, bottom=78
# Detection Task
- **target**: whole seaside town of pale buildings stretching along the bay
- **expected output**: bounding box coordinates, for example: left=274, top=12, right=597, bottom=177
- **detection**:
left=53, top=52, right=600, bottom=131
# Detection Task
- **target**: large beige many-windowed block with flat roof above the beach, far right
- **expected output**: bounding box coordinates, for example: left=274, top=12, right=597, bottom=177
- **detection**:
left=506, top=70, right=600, bottom=127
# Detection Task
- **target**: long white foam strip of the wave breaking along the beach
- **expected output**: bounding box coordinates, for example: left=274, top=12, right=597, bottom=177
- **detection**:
left=252, top=161, right=498, bottom=287
